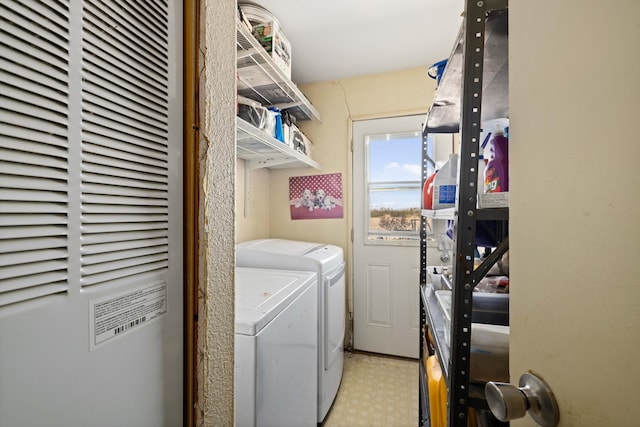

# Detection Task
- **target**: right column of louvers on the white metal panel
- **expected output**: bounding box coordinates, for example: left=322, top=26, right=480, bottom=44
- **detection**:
left=81, top=1, right=169, bottom=286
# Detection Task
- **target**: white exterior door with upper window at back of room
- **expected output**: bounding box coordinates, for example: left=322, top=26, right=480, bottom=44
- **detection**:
left=353, top=116, right=424, bottom=358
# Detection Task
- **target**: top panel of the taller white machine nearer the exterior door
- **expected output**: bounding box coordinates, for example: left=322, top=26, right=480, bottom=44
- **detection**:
left=236, top=239, right=344, bottom=273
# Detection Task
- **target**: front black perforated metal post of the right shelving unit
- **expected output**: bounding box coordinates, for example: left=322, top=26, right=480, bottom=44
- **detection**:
left=448, top=0, right=486, bottom=426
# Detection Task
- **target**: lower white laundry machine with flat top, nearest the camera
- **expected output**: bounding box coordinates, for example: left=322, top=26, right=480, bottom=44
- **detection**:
left=234, top=268, right=318, bottom=427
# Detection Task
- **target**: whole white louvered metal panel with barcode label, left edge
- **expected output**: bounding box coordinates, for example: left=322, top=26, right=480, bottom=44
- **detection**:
left=0, top=0, right=183, bottom=427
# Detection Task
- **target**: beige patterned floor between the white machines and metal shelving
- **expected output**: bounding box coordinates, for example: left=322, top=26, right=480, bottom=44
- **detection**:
left=323, top=353, right=419, bottom=427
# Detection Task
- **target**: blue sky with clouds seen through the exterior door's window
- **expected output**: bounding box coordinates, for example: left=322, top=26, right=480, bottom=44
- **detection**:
left=369, top=135, right=422, bottom=209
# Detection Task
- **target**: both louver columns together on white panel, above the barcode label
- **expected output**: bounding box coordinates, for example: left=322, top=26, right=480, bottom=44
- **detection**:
left=0, top=0, right=169, bottom=307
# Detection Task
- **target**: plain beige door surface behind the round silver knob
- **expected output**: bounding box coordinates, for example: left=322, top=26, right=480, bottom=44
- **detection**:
left=509, top=0, right=640, bottom=427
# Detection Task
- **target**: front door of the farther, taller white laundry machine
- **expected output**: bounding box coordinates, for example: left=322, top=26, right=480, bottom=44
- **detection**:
left=323, top=262, right=346, bottom=370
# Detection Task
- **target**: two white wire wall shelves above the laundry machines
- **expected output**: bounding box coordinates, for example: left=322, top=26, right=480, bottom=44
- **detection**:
left=236, top=22, right=320, bottom=169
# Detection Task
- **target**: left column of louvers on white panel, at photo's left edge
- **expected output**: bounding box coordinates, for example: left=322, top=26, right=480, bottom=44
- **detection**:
left=0, top=1, right=69, bottom=307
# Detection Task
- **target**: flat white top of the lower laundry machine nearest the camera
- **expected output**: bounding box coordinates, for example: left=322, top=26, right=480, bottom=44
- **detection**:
left=235, top=267, right=316, bottom=335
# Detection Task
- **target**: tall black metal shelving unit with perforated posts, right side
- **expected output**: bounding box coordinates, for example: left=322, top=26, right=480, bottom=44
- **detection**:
left=419, top=0, right=509, bottom=426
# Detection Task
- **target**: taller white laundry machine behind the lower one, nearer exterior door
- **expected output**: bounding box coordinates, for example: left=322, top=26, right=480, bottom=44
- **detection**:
left=236, top=239, right=346, bottom=422
